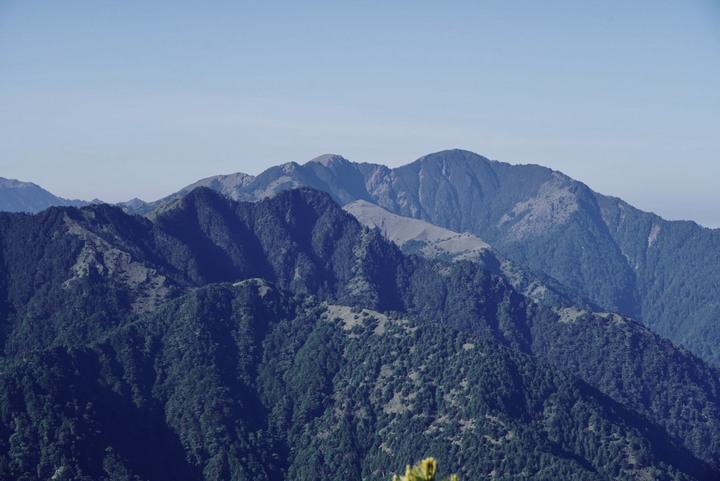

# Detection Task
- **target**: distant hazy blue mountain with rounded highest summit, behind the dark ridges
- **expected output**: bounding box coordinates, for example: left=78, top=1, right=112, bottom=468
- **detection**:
left=161, top=150, right=720, bottom=365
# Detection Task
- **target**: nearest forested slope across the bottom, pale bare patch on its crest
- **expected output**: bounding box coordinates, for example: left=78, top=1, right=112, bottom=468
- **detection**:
left=0, top=280, right=714, bottom=480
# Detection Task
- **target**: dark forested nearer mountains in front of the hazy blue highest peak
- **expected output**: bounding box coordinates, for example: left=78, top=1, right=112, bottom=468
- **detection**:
left=0, top=188, right=720, bottom=479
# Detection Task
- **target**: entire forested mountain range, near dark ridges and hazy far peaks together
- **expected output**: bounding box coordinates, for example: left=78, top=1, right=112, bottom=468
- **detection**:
left=0, top=151, right=720, bottom=480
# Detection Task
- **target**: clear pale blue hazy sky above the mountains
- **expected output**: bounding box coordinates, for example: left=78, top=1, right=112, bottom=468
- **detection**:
left=0, top=0, right=720, bottom=227
